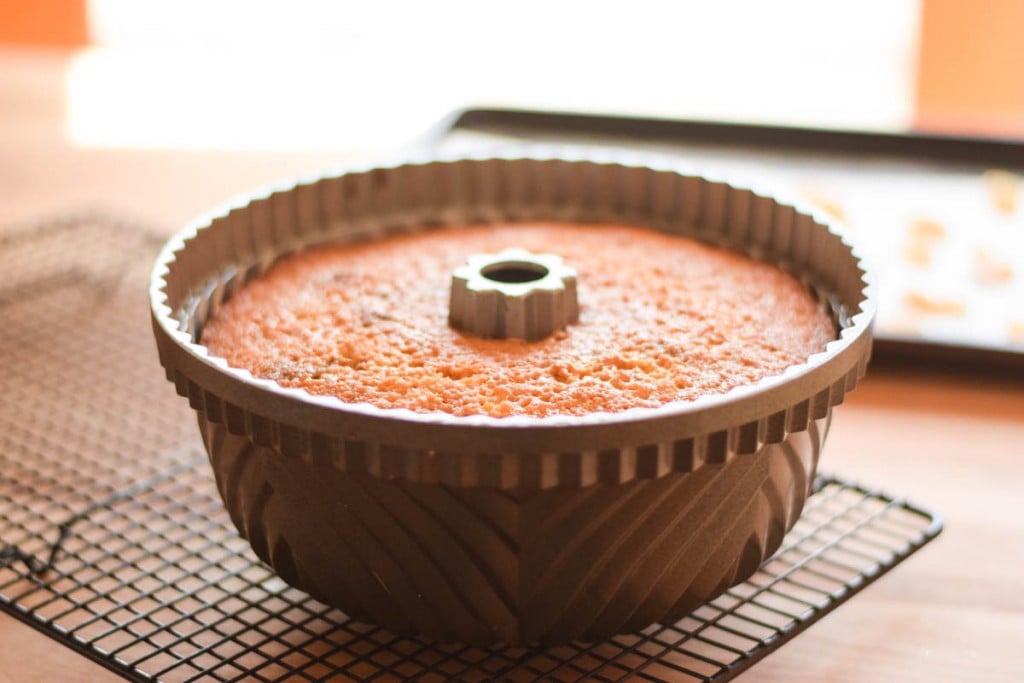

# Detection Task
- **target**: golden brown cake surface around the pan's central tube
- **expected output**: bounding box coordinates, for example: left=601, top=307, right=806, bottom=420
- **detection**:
left=202, top=222, right=836, bottom=417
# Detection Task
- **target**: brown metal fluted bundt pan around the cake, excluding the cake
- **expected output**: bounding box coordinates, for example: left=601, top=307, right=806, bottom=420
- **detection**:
left=151, top=151, right=874, bottom=645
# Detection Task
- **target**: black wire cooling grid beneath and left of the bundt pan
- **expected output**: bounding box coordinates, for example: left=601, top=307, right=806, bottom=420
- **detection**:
left=0, top=217, right=941, bottom=681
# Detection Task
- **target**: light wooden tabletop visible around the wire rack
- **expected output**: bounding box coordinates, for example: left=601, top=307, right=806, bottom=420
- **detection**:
left=0, top=51, right=1024, bottom=683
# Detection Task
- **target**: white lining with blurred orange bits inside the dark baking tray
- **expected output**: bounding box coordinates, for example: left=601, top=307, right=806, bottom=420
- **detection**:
left=441, top=130, right=1024, bottom=352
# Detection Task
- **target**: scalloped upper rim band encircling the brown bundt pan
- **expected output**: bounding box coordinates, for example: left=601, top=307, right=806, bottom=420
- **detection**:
left=150, top=146, right=877, bottom=481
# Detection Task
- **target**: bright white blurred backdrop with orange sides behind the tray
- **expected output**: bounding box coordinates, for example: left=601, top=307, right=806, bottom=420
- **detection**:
left=8, top=0, right=1024, bottom=151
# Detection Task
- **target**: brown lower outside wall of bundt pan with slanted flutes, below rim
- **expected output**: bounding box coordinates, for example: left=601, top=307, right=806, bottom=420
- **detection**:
left=200, top=415, right=827, bottom=645
